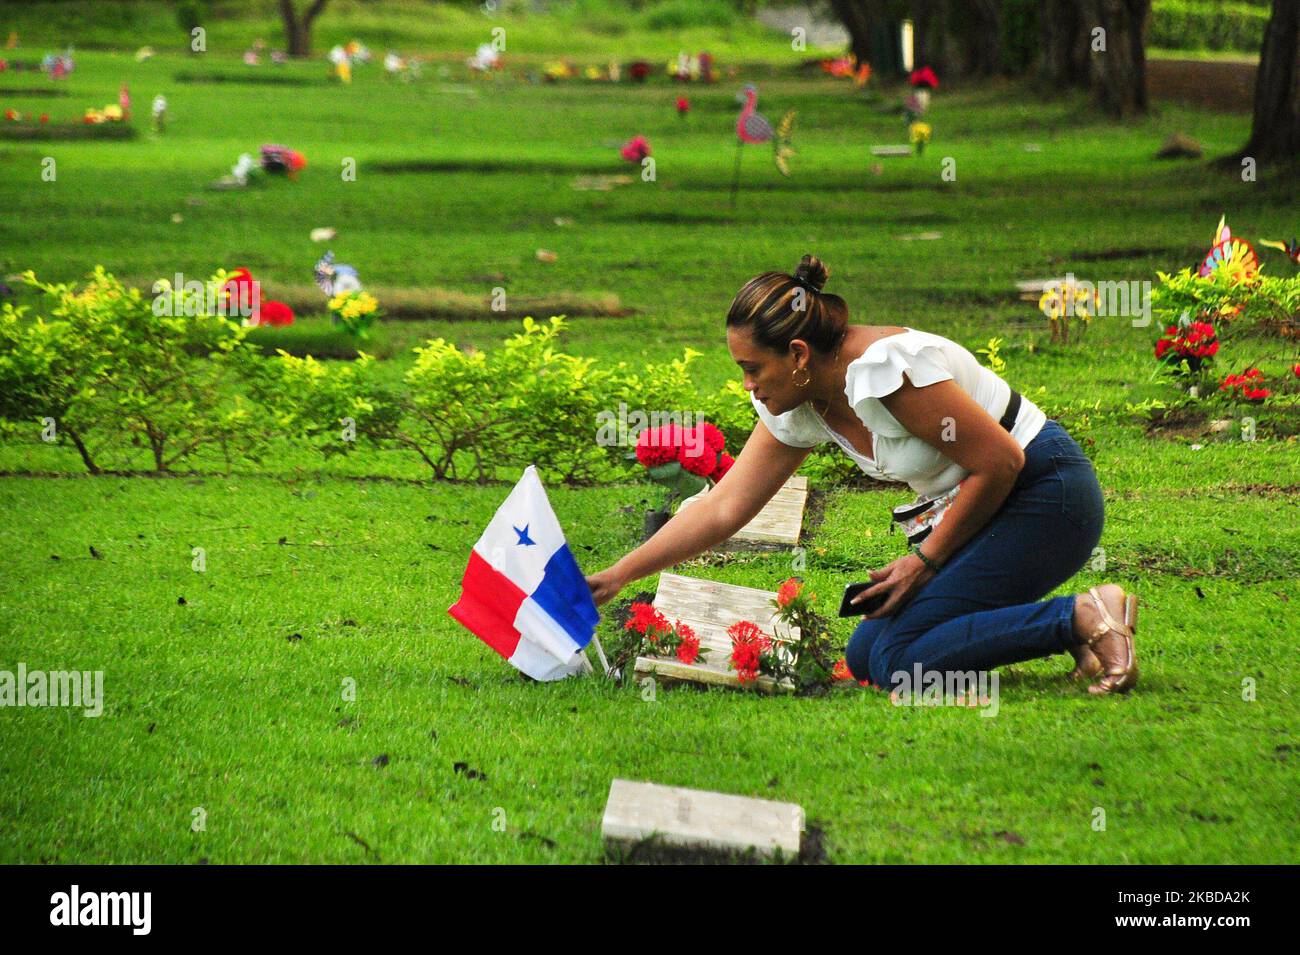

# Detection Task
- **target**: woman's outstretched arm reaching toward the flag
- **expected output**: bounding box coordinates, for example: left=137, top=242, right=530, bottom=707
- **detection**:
left=586, top=421, right=813, bottom=604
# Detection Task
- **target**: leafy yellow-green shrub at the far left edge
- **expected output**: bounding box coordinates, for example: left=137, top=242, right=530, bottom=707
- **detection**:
left=0, top=266, right=269, bottom=473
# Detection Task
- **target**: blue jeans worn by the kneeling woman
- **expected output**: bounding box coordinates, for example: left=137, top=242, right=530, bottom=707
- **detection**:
left=845, top=420, right=1104, bottom=689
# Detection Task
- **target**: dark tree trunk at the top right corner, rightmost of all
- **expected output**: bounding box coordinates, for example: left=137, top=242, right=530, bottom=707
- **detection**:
left=1238, top=0, right=1300, bottom=162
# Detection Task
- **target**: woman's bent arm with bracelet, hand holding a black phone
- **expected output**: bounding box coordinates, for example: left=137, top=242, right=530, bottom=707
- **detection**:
left=855, top=377, right=1024, bottom=618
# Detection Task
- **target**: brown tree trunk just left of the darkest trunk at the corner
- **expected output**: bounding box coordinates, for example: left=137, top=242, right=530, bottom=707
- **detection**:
left=1083, top=0, right=1151, bottom=118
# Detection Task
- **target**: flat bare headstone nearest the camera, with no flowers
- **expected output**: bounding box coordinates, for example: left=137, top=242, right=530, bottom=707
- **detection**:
left=601, top=780, right=803, bottom=859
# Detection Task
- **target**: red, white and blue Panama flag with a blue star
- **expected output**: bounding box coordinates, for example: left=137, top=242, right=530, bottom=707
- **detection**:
left=447, top=464, right=601, bottom=680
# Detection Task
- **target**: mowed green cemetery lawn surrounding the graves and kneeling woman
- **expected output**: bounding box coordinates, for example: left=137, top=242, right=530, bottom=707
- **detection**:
left=0, top=27, right=1300, bottom=863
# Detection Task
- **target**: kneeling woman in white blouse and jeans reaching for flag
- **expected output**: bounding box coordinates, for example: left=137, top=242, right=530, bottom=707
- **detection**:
left=588, top=256, right=1138, bottom=694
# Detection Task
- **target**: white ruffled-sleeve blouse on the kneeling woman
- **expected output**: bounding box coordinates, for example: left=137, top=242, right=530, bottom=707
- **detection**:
left=749, top=329, right=1047, bottom=496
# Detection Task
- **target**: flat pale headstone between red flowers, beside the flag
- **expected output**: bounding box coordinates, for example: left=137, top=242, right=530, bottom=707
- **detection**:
left=636, top=573, right=800, bottom=693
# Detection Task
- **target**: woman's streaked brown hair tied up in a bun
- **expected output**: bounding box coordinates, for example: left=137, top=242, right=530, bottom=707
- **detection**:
left=727, top=255, right=849, bottom=353
